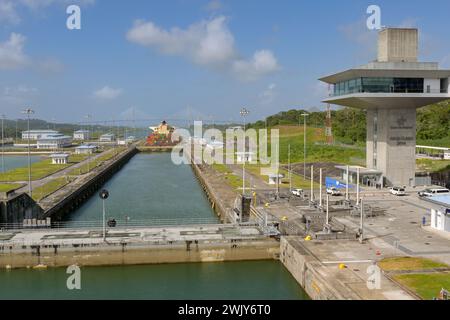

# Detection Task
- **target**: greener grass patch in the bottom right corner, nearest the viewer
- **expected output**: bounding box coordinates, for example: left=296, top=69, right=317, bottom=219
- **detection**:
left=394, top=272, right=450, bottom=300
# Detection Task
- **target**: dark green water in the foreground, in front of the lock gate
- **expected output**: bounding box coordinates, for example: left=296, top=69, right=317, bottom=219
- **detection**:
left=0, top=261, right=307, bottom=300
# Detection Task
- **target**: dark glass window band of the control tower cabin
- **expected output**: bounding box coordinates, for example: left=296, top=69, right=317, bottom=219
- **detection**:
left=333, top=78, right=432, bottom=96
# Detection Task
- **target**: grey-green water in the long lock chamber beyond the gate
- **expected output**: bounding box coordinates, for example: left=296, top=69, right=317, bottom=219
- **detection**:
left=68, top=153, right=218, bottom=222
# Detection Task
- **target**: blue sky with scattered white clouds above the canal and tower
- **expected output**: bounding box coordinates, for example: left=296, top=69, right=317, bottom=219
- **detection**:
left=0, top=0, right=450, bottom=122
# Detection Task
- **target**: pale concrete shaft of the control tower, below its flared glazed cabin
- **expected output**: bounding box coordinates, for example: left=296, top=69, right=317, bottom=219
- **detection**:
left=367, top=108, right=416, bottom=186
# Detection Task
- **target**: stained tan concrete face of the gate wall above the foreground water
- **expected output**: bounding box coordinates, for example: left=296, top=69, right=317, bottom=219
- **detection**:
left=0, top=239, right=279, bottom=269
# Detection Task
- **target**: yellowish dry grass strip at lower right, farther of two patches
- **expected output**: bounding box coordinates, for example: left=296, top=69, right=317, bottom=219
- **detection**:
left=378, top=257, right=448, bottom=271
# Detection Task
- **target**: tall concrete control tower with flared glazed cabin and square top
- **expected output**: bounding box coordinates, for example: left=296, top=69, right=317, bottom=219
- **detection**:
left=320, top=28, right=450, bottom=186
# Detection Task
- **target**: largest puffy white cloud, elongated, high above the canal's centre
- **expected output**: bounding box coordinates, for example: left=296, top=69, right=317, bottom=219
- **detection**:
left=127, top=16, right=279, bottom=80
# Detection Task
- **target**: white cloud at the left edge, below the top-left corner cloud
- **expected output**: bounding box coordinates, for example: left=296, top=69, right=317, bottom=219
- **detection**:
left=0, top=33, right=29, bottom=70
